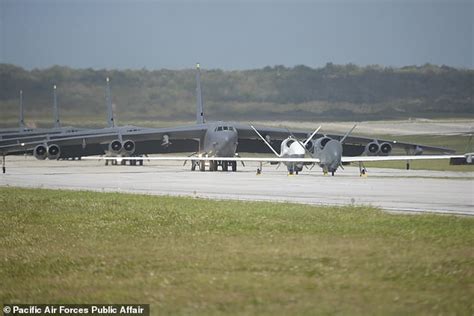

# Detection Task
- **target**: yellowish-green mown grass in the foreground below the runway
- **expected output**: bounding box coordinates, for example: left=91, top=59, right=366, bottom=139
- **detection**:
left=0, top=187, right=474, bottom=315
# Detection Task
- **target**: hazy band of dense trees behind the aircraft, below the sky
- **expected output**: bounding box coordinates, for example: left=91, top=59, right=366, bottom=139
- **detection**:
left=0, top=63, right=474, bottom=125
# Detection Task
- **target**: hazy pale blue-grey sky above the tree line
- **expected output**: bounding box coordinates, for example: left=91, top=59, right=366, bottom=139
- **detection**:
left=0, top=0, right=474, bottom=69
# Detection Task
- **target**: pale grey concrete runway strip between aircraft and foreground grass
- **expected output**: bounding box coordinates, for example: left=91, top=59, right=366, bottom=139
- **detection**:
left=0, top=157, right=474, bottom=215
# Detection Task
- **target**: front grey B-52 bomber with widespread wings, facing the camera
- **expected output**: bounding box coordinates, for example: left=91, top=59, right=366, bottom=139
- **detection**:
left=0, top=64, right=454, bottom=171
